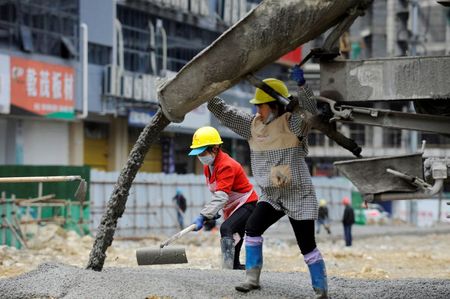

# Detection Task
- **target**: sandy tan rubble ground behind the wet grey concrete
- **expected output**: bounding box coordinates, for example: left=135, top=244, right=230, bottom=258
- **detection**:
left=0, top=225, right=450, bottom=280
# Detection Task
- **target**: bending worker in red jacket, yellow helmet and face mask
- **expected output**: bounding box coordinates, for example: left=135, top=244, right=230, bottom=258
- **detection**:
left=189, top=126, right=258, bottom=269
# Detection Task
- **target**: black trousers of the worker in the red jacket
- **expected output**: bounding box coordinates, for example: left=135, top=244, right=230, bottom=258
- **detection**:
left=220, top=201, right=256, bottom=268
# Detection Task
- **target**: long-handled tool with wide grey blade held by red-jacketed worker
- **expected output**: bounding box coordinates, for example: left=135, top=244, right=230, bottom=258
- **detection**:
left=136, top=224, right=196, bottom=266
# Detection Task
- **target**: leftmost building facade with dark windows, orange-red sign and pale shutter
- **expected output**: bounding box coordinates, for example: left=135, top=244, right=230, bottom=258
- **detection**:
left=0, top=1, right=80, bottom=165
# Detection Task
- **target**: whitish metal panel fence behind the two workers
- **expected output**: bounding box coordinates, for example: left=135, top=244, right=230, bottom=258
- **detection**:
left=90, top=170, right=352, bottom=238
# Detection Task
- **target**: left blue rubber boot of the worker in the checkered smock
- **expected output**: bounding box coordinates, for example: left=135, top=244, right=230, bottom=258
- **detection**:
left=235, top=237, right=263, bottom=293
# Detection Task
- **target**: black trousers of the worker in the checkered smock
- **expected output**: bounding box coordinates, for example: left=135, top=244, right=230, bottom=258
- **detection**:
left=245, top=201, right=316, bottom=255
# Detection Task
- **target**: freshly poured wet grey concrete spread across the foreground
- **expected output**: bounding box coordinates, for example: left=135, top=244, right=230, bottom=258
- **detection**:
left=0, top=263, right=450, bottom=299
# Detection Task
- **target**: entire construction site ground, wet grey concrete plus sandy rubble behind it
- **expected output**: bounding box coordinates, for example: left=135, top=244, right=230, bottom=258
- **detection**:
left=0, top=220, right=450, bottom=298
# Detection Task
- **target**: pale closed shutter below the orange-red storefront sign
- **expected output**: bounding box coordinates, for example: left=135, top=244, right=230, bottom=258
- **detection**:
left=22, top=120, right=69, bottom=165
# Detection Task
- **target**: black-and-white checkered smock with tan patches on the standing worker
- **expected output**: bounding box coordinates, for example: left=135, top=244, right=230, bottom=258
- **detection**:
left=208, top=87, right=318, bottom=220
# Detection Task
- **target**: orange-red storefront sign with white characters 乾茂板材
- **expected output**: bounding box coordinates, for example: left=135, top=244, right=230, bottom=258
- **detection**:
left=10, top=56, right=75, bottom=119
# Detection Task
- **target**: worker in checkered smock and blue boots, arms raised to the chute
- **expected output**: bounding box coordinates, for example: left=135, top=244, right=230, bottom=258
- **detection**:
left=208, top=67, right=328, bottom=298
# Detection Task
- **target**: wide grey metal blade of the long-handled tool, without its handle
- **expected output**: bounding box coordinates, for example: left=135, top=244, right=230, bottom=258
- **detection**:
left=136, top=247, right=188, bottom=266
